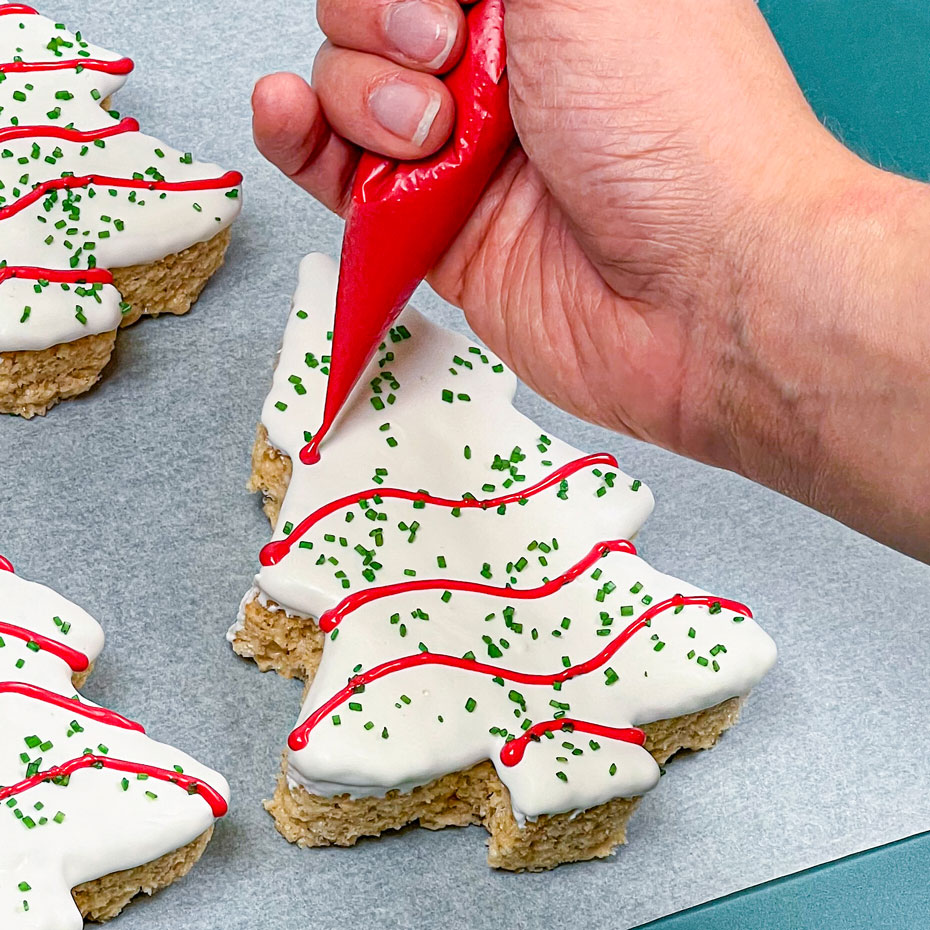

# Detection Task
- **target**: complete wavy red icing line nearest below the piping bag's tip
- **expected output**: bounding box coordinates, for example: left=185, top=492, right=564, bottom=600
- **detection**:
left=259, top=452, right=620, bottom=565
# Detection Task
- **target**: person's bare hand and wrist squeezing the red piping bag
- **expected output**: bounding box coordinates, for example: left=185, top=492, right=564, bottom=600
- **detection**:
left=253, top=0, right=930, bottom=560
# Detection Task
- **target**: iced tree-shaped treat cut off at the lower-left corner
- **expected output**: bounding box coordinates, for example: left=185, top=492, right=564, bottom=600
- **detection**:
left=0, top=557, right=229, bottom=930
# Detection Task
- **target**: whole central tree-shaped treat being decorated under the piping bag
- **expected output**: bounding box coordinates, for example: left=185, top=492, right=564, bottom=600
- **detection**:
left=230, top=256, right=775, bottom=869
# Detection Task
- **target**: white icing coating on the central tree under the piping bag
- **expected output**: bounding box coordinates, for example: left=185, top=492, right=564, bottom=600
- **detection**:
left=248, top=255, right=775, bottom=822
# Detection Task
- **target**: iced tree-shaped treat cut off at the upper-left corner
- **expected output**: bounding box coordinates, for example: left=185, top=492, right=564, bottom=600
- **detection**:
left=0, top=3, right=242, bottom=417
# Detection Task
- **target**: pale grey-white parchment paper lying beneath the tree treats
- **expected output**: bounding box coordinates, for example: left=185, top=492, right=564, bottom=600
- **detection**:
left=0, top=0, right=930, bottom=930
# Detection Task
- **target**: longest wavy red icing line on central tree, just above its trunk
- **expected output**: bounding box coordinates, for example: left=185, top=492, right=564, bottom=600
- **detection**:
left=287, top=594, right=752, bottom=751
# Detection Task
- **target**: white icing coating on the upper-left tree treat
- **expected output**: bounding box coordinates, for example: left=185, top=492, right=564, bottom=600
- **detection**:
left=0, top=5, right=241, bottom=351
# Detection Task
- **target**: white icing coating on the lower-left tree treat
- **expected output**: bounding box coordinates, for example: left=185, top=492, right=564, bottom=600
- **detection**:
left=0, top=571, right=229, bottom=930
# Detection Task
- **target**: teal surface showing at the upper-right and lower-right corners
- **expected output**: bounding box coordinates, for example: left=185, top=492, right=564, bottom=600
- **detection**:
left=644, top=0, right=930, bottom=930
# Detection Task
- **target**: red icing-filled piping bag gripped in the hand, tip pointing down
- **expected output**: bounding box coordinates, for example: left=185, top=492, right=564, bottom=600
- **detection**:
left=300, top=0, right=515, bottom=465
